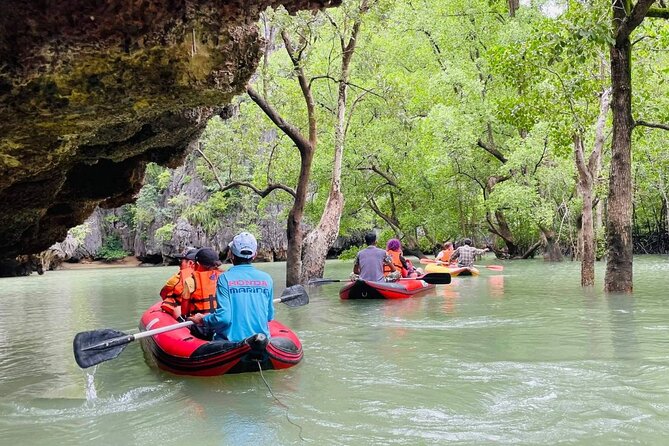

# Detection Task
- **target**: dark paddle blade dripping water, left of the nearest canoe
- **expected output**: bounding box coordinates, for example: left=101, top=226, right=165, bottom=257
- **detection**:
left=73, top=328, right=134, bottom=369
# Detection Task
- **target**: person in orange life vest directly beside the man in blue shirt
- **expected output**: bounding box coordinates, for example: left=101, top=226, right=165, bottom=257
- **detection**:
left=181, top=248, right=222, bottom=340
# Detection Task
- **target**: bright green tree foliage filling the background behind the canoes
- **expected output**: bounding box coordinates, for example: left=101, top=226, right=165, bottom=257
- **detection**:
left=121, top=0, right=669, bottom=258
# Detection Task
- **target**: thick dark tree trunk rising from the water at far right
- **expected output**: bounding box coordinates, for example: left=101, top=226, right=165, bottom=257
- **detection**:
left=604, top=37, right=633, bottom=293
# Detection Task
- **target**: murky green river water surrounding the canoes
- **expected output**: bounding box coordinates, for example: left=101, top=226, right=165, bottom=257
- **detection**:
left=0, top=256, right=669, bottom=446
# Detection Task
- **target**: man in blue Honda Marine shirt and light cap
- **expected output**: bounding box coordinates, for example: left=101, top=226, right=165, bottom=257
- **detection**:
left=189, top=232, right=274, bottom=342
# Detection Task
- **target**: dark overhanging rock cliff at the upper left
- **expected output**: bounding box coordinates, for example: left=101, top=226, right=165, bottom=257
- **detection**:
left=0, top=0, right=341, bottom=257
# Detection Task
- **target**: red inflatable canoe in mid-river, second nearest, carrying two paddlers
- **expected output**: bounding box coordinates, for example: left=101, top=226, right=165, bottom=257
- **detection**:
left=339, top=279, right=435, bottom=299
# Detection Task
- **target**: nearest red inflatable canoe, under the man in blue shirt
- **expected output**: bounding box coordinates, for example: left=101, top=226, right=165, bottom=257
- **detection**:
left=139, top=302, right=303, bottom=376
